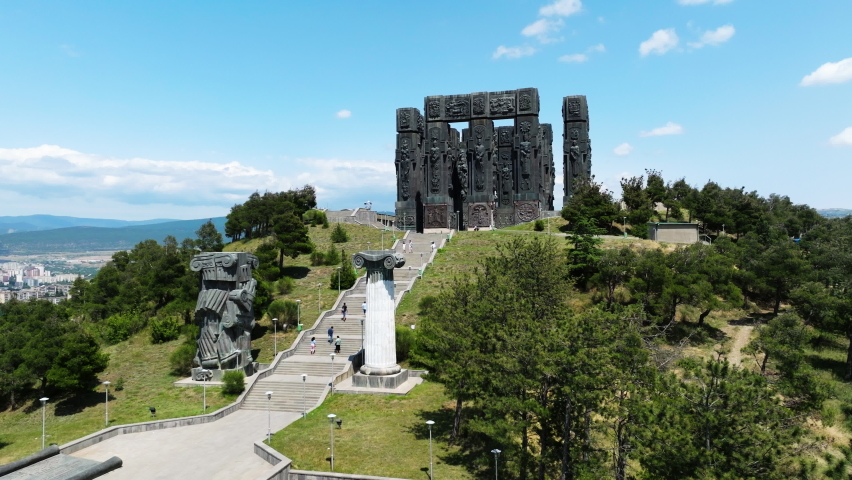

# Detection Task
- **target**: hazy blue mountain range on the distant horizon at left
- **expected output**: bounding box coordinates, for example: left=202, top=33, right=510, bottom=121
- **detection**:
left=0, top=215, right=226, bottom=255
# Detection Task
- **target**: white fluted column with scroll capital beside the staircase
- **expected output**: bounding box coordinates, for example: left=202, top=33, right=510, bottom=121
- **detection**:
left=352, top=250, right=408, bottom=389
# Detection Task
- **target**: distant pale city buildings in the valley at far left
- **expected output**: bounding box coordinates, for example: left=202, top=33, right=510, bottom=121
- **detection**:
left=0, top=262, right=80, bottom=303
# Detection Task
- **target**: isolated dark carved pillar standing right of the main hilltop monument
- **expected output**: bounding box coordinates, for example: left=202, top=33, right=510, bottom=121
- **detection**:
left=562, top=95, right=592, bottom=205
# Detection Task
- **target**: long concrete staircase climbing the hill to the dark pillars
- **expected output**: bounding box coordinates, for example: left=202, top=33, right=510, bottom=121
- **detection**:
left=242, top=232, right=447, bottom=412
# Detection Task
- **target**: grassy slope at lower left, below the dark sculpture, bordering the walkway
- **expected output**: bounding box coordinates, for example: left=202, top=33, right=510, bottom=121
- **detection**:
left=0, top=331, right=235, bottom=464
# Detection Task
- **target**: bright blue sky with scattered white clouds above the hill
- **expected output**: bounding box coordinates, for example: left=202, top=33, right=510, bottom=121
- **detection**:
left=0, top=0, right=852, bottom=220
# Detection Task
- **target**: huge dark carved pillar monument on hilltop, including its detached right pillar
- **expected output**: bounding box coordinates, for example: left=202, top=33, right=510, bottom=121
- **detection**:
left=395, top=88, right=591, bottom=231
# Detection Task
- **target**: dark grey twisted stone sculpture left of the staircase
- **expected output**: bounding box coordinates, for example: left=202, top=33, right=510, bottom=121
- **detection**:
left=189, top=252, right=258, bottom=380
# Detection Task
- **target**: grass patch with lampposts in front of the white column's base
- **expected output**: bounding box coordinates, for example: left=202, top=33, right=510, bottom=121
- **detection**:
left=272, top=382, right=474, bottom=479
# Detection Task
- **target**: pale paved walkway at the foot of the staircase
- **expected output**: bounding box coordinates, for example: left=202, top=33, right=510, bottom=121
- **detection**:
left=72, top=410, right=301, bottom=480
